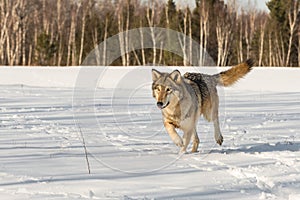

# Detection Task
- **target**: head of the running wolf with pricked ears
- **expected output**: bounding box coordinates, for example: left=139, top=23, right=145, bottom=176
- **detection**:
left=152, top=69, right=183, bottom=109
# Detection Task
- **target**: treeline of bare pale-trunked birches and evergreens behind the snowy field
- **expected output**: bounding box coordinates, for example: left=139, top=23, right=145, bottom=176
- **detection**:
left=0, top=0, right=300, bottom=67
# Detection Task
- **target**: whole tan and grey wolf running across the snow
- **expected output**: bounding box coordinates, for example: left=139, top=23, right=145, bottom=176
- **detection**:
left=152, top=59, right=254, bottom=152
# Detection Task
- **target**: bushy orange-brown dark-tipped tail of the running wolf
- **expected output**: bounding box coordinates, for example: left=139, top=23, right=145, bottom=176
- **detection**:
left=215, top=59, right=254, bottom=87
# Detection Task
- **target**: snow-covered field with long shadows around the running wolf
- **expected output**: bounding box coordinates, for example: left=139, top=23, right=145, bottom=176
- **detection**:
left=0, top=67, right=300, bottom=200
